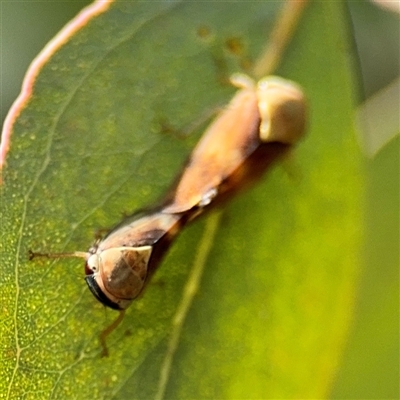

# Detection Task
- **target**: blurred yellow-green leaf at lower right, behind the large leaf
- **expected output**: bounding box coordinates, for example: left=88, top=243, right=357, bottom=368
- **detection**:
left=331, top=136, right=400, bottom=399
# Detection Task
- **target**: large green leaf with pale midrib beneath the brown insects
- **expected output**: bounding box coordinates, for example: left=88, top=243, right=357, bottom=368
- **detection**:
left=0, top=2, right=363, bottom=399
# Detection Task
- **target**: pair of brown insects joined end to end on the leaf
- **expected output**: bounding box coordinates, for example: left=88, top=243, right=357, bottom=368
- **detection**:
left=31, top=75, right=307, bottom=310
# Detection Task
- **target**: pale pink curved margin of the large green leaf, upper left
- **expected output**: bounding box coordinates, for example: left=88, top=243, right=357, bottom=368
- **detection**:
left=0, top=0, right=115, bottom=179
